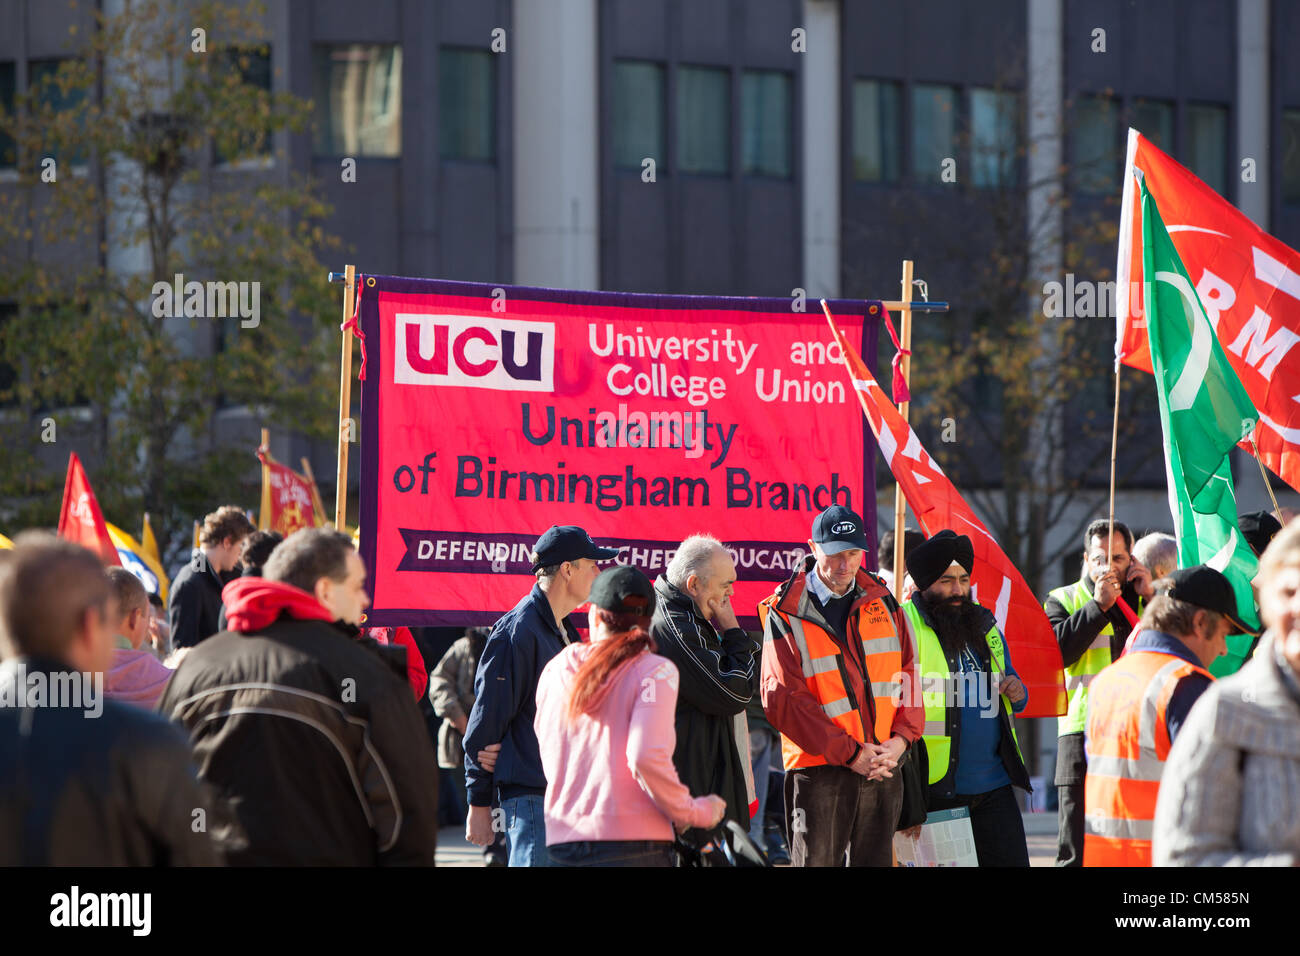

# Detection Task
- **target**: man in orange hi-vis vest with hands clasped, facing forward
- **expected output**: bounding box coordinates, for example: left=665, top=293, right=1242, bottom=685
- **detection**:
left=758, top=505, right=924, bottom=866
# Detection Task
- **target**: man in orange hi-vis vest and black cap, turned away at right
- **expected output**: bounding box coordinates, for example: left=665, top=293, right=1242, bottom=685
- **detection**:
left=1083, top=564, right=1253, bottom=866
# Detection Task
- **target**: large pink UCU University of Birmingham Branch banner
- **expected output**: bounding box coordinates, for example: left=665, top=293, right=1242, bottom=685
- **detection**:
left=358, top=276, right=880, bottom=628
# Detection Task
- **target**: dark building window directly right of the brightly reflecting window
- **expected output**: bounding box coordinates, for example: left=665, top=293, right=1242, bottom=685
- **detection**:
left=438, top=47, right=497, bottom=163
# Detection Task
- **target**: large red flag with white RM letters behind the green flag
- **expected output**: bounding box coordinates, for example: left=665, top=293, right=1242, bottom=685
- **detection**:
left=1115, top=129, right=1300, bottom=489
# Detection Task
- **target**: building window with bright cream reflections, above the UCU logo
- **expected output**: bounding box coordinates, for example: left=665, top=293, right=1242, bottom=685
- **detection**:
left=312, top=43, right=402, bottom=156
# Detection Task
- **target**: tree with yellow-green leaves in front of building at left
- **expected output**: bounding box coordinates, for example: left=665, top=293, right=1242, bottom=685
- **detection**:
left=0, top=0, right=338, bottom=556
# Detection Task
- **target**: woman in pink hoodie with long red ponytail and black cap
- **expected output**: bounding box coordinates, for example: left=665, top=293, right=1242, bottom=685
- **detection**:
left=533, top=567, right=727, bottom=866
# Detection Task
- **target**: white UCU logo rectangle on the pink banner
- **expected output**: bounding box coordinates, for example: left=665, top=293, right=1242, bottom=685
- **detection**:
left=393, top=312, right=555, bottom=392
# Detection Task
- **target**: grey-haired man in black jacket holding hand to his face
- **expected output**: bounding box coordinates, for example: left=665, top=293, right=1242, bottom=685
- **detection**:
left=650, top=535, right=761, bottom=842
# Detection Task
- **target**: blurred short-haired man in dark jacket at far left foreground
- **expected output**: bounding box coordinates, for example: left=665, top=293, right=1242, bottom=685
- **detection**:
left=0, top=533, right=217, bottom=866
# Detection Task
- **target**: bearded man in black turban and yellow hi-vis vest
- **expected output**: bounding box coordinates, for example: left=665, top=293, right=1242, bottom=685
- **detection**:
left=904, top=529, right=1030, bottom=866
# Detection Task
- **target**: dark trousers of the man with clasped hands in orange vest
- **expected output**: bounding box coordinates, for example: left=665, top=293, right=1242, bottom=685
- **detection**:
left=785, top=766, right=902, bottom=866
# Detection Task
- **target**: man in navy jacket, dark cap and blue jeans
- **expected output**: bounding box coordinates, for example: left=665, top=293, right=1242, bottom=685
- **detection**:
left=464, top=525, right=618, bottom=866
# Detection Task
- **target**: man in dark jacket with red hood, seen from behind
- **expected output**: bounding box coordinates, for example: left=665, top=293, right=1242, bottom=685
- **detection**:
left=159, top=528, right=438, bottom=866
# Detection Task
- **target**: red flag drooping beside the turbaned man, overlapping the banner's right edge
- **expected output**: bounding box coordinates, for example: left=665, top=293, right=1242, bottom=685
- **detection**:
left=822, top=303, right=1066, bottom=717
